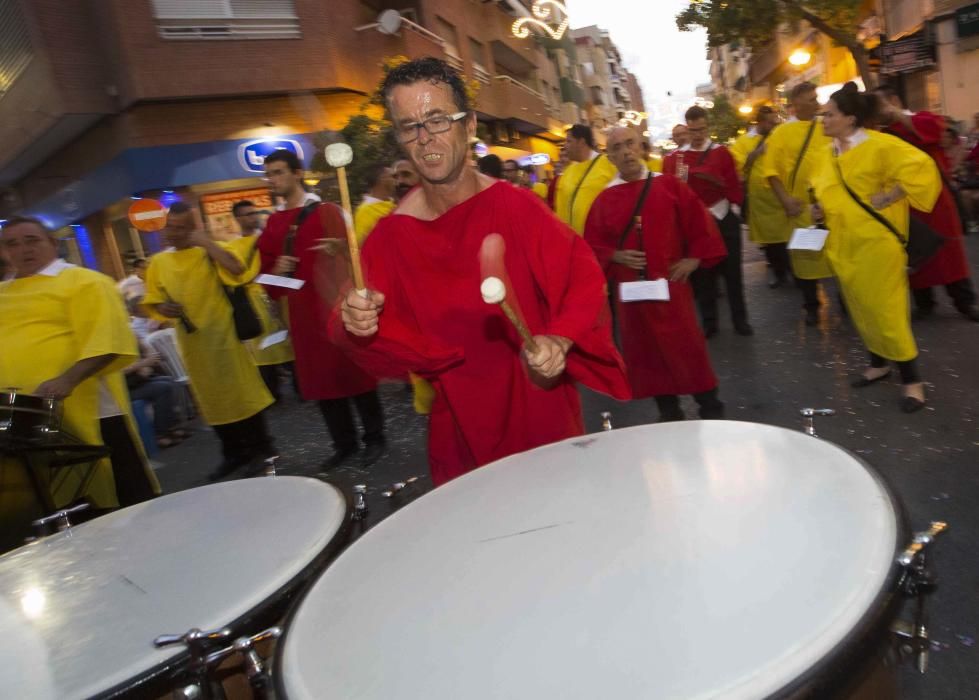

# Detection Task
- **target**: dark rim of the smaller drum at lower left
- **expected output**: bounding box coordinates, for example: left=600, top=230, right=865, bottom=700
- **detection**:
left=81, top=475, right=353, bottom=700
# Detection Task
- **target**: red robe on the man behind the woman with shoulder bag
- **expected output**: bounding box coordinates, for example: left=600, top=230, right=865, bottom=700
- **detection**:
left=884, top=112, right=969, bottom=289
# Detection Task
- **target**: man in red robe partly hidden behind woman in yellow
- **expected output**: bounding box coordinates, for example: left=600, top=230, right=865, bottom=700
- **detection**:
left=875, top=85, right=979, bottom=321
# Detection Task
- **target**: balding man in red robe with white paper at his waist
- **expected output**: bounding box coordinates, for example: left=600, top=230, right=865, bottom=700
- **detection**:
left=585, top=127, right=727, bottom=421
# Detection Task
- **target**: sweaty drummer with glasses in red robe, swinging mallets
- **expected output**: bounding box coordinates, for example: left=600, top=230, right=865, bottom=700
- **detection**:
left=332, top=58, right=629, bottom=485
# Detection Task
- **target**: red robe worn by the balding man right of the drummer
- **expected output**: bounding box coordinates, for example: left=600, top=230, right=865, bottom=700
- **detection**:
left=585, top=176, right=727, bottom=399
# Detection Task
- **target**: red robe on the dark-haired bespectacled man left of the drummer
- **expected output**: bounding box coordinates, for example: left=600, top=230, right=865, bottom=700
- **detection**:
left=258, top=203, right=377, bottom=401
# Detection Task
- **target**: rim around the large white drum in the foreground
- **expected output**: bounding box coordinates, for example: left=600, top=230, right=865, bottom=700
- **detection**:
left=272, top=421, right=910, bottom=700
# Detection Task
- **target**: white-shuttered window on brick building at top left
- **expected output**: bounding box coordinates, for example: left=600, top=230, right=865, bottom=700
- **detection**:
left=152, top=0, right=302, bottom=39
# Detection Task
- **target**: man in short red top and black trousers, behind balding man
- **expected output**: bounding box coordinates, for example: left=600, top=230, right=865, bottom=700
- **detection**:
left=663, top=106, right=754, bottom=338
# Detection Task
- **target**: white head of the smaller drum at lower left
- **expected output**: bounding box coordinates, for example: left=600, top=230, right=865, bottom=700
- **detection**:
left=0, top=477, right=346, bottom=700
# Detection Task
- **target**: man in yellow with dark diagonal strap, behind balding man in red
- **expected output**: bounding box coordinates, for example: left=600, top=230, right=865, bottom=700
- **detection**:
left=554, top=124, right=619, bottom=236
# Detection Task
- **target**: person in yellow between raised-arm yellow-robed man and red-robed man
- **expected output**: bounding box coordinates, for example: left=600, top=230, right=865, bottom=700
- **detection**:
left=233, top=199, right=298, bottom=401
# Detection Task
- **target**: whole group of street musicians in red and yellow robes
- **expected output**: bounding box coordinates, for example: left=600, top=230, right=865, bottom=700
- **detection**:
left=0, top=58, right=979, bottom=540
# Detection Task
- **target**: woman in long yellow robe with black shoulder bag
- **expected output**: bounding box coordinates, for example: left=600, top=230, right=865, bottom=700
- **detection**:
left=812, top=83, right=942, bottom=413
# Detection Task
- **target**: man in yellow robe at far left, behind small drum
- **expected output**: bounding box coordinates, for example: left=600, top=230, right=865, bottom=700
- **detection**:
left=0, top=217, right=160, bottom=548
